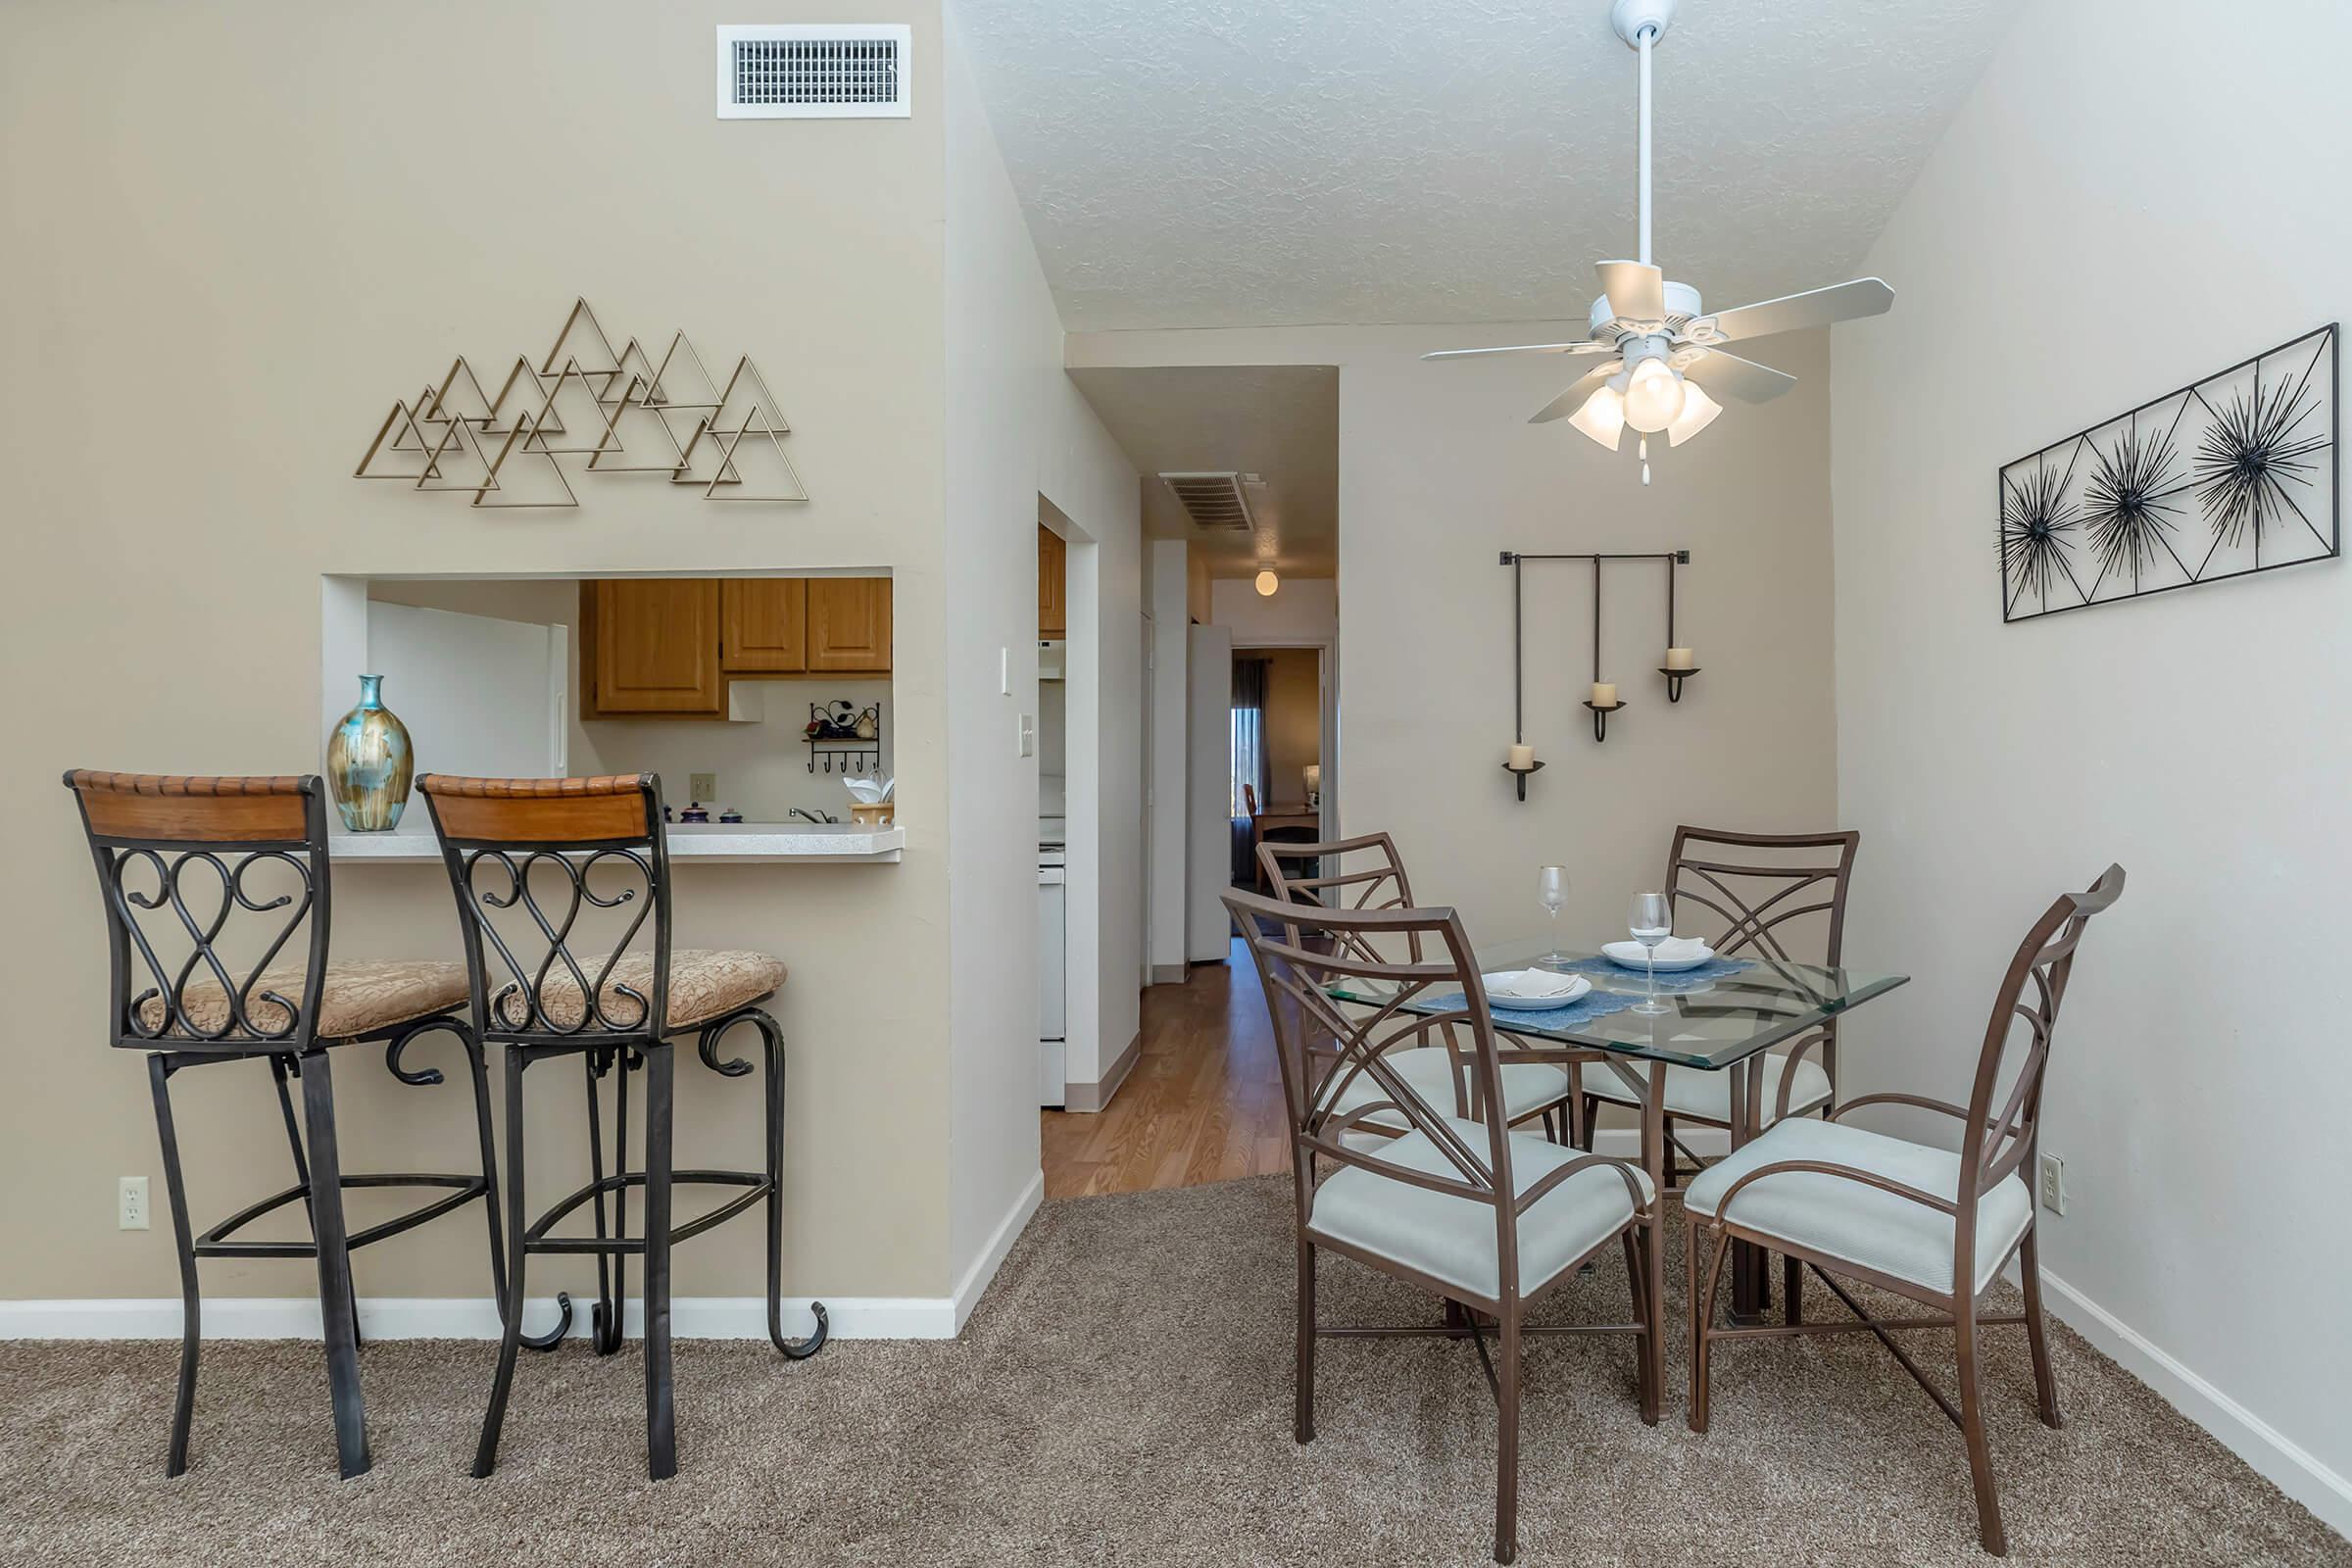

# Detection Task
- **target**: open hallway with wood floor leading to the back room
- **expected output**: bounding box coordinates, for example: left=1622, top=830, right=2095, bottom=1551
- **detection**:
left=1042, top=365, right=1341, bottom=1197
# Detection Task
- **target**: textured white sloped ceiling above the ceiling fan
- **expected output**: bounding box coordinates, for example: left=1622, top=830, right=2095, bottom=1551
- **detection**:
left=959, top=0, right=2023, bottom=331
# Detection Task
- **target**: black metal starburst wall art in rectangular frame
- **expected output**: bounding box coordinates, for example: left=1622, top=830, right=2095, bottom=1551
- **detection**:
left=1999, top=322, right=2340, bottom=620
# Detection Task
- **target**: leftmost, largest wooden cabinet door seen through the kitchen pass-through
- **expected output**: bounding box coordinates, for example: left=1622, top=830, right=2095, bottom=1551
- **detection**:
left=581, top=578, right=727, bottom=717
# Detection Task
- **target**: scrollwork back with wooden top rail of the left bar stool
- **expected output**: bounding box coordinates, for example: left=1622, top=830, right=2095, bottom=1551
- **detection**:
left=66, top=768, right=331, bottom=1054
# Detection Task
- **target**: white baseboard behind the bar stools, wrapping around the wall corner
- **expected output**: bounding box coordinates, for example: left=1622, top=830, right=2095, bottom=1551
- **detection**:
left=0, top=1171, right=1045, bottom=1340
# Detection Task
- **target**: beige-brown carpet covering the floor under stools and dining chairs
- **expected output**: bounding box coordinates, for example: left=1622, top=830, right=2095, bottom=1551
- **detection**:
left=0, top=1178, right=2352, bottom=1568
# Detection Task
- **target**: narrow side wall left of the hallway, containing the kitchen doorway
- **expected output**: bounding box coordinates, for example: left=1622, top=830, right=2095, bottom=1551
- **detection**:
left=946, top=7, right=1143, bottom=1279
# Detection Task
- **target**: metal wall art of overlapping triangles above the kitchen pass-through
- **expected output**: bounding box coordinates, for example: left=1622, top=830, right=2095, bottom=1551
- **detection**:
left=353, top=296, right=809, bottom=511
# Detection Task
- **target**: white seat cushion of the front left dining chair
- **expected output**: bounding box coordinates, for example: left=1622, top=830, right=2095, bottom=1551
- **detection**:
left=1307, top=1116, right=1651, bottom=1300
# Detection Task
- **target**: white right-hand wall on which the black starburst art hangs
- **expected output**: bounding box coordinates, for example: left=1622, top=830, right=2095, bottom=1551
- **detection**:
left=1835, top=0, right=2352, bottom=1528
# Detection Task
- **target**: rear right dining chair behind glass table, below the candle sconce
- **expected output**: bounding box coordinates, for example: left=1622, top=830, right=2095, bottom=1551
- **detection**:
left=1576, top=827, right=1863, bottom=1203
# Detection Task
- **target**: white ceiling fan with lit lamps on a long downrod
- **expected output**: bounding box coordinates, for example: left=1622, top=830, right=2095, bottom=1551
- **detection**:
left=1421, top=0, right=1895, bottom=484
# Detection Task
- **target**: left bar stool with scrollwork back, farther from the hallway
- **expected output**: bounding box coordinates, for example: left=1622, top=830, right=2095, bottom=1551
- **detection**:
left=66, top=768, right=506, bottom=1481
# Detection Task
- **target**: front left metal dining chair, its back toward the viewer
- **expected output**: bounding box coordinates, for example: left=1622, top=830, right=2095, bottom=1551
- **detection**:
left=1225, top=891, right=1663, bottom=1563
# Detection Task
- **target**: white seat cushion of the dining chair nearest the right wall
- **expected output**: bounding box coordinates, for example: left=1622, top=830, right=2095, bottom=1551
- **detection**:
left=1682, top=1119, right=2034, bottom=1293
